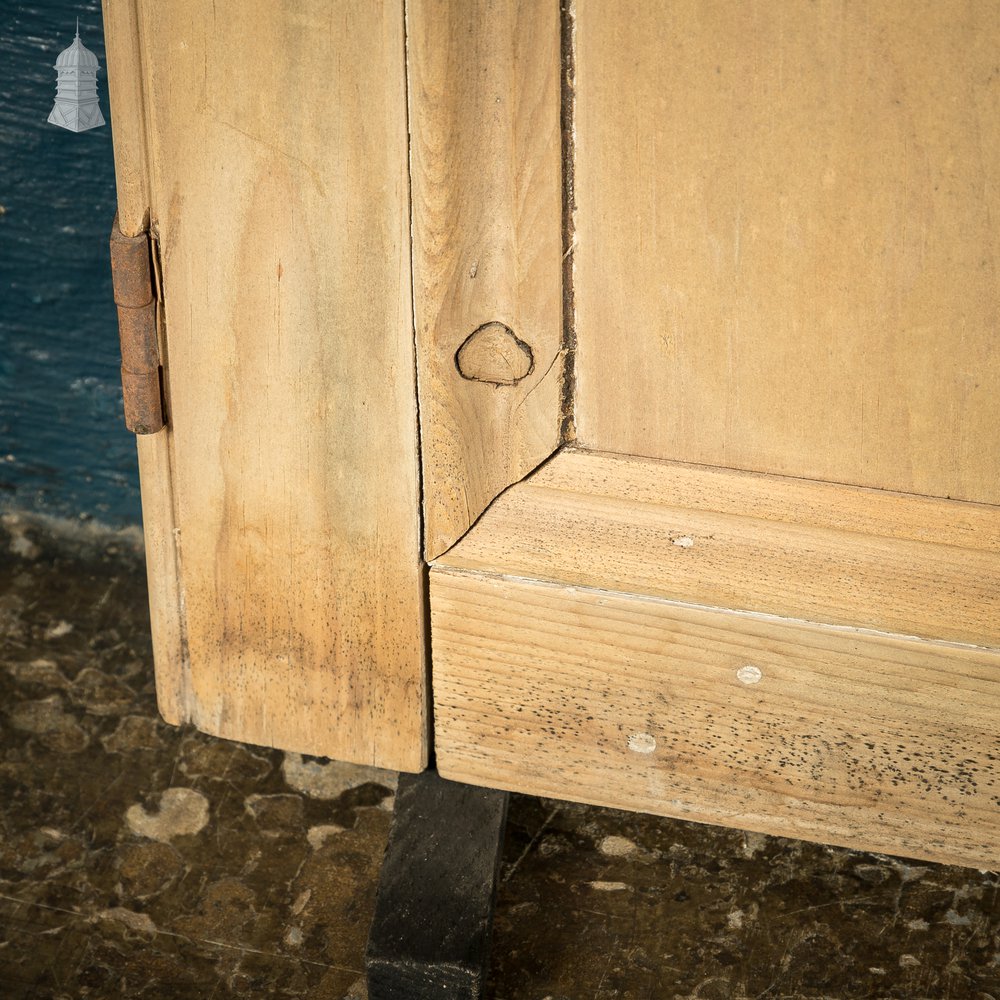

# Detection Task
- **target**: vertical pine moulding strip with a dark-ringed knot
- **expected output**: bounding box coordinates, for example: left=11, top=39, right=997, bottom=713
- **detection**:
left=407, top=0, right=563, bottom=558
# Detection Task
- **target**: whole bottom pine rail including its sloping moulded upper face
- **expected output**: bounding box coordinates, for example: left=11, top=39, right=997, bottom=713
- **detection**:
left=431, top=451, right=1000, bottom=867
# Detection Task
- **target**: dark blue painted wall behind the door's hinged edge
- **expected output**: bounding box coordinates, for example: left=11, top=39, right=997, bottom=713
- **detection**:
left=0, top=0, right=140, bottom=527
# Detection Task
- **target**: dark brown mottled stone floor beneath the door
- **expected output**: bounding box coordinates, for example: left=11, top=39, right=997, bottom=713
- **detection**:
left=0, top=515, right=1000, bottom=1000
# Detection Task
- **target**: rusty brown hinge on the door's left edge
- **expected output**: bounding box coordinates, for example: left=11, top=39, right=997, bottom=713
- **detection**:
left=111, top=215, right=166, bottom=434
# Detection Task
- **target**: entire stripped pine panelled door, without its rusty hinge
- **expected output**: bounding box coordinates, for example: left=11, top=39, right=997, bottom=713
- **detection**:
left=105, top=0, right=1000, bottom=867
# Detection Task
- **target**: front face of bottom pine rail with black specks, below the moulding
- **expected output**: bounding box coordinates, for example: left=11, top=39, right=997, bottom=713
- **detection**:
left=431, top=572, right=1000, bottom=869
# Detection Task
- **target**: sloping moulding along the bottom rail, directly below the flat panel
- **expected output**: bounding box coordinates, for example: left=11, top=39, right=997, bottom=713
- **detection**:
left=437, top=451, right=1000, bottom=647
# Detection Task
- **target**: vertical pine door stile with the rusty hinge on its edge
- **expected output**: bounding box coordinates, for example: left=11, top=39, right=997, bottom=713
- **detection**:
left=104, top=0, right=427, bottom=770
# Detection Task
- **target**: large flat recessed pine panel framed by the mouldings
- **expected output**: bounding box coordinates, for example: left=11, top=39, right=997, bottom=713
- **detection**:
left=574, top=0, right=1000, bottom=503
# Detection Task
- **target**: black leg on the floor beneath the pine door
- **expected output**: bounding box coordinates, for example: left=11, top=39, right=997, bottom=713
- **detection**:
left=366, top=771, right=510, bottom=1000
